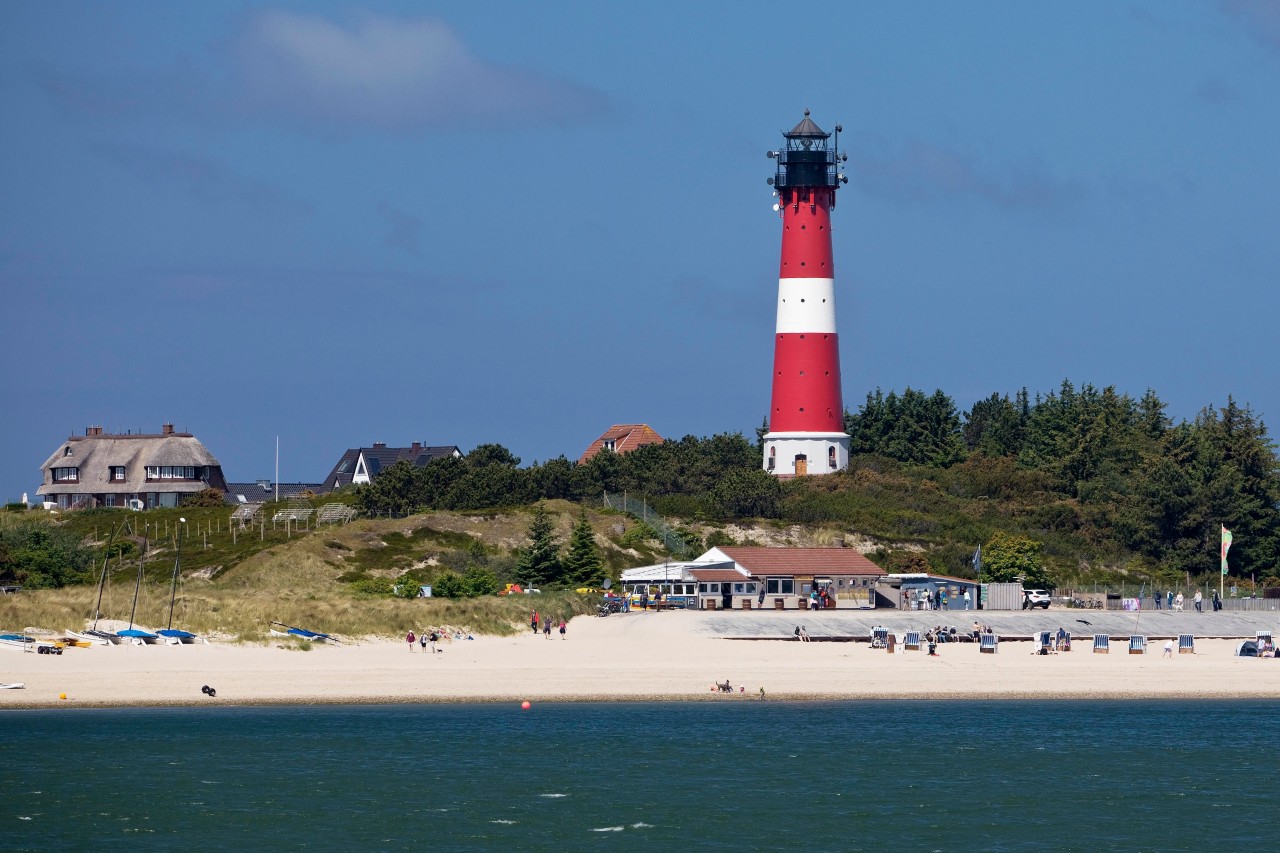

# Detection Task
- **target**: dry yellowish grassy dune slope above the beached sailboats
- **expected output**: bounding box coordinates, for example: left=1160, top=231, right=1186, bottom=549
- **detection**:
left=0, top=501, right=660, bottom=640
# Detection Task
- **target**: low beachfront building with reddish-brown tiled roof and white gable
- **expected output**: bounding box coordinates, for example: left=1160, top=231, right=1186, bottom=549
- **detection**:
left=698, top=546, right=886, bottom=610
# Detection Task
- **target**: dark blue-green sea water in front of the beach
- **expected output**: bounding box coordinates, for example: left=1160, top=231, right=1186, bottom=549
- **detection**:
left=0, top=697, right=1280, bottom=853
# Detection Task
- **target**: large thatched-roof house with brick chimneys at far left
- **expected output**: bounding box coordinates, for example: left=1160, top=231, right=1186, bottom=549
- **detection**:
left=36, top=424, right=227, bottom=510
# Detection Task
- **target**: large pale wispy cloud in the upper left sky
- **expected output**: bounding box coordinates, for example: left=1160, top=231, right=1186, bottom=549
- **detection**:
left=236, top=12, right=607, bottom=131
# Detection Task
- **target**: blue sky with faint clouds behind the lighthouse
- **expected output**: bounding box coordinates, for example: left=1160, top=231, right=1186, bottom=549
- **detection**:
left=0, top=0, right=1280, bottom=500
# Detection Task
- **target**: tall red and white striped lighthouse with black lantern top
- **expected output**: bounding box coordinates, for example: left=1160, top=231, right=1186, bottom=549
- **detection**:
left=764, top=110, right=849, bottom=476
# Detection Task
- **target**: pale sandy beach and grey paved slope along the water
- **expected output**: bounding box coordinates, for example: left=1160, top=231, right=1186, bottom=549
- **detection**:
left=0, top=611, right=1280, bottom=710
